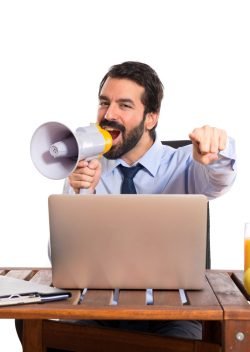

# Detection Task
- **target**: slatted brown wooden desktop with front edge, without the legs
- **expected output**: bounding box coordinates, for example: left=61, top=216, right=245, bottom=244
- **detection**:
left=0, top=268, right=250, bottom=320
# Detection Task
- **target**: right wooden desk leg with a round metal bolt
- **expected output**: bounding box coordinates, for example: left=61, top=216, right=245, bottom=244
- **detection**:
left=223, top=320, right=250, bottom=352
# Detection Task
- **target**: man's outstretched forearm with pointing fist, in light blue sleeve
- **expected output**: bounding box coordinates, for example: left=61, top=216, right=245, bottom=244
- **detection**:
left=188, top=126, right=236, bottom=199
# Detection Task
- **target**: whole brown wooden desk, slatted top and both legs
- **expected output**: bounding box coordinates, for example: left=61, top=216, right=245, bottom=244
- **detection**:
left=0, top=268, right=250, bottom=352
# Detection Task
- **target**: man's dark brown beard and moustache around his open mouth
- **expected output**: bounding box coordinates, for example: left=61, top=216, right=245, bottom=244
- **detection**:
left=100, top=117, right=145, bottom=159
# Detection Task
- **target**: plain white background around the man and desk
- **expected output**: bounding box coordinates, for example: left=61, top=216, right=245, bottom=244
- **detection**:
left=0, top=0, right=250, bottom=352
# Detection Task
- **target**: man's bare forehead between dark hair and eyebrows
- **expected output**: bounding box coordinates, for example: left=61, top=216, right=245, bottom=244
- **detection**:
left=100, top=77, right=144, bottom=101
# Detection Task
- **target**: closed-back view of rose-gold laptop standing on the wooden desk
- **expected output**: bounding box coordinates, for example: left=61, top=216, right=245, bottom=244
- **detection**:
left=49, top=194, right=207, bottom=290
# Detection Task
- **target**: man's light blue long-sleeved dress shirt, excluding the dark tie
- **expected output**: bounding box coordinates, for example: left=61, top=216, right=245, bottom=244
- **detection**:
left=64, top=137, right=236, bottom=199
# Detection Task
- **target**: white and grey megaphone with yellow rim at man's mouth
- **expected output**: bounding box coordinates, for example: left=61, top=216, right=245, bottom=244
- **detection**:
left=30, top=121, right=112, bottom=180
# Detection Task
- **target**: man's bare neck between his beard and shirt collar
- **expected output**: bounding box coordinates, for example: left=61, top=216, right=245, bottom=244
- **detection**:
left=121, top=133, right=154, bottom=165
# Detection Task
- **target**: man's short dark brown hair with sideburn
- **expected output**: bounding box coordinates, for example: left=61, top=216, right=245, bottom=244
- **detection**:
left=99, top=61, right=163, bottom=139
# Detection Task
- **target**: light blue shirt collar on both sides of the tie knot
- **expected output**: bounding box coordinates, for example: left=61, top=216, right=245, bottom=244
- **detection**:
left=101, top=137, right=164, bottom=176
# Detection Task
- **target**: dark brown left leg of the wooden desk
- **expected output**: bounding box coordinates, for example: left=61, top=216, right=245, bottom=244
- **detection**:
left=23, top=319, right=45, bottom=352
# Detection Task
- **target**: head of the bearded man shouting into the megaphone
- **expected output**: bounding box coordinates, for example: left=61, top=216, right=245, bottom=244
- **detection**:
left=98, top=61, right=163, bottom=159
